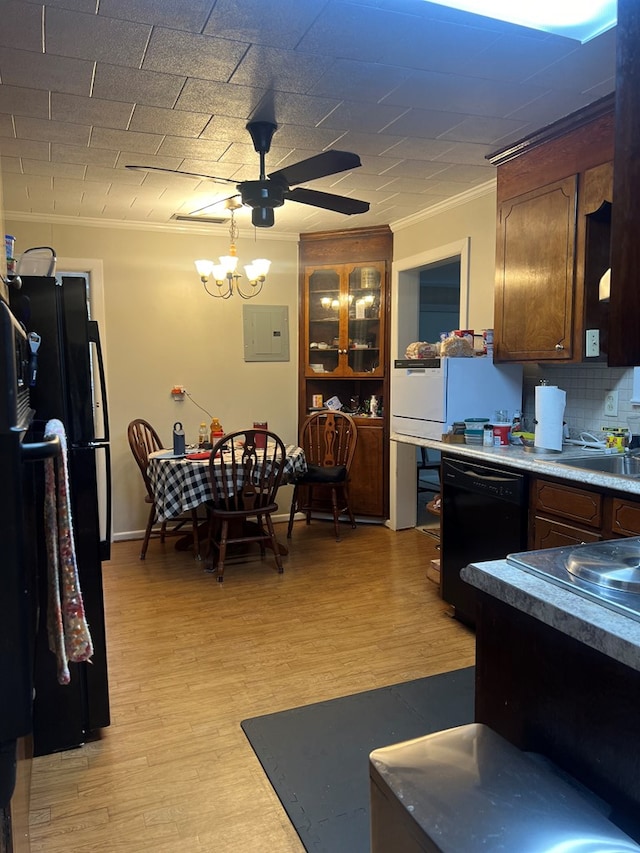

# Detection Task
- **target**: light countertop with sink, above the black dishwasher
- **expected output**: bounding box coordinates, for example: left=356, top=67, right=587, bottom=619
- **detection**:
left=391, top=433, right=640, bottom=496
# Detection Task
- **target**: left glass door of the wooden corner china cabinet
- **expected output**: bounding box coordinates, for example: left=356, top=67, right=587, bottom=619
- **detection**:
left=306, top=267, right=341, bottom=375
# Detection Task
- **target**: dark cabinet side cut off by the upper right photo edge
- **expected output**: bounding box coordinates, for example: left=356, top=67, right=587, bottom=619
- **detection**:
left=609, top=0, right=640, bottom=367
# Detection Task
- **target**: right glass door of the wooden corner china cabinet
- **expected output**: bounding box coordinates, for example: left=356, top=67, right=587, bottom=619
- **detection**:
left=346, top=263, right=384, bottom=375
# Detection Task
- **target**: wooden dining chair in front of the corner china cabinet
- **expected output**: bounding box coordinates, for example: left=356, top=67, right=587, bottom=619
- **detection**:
left=287, top=410, right=358, bottom=542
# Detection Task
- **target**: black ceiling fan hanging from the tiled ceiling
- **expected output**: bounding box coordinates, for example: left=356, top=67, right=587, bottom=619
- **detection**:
left=126, top=121, right=369, bottom=228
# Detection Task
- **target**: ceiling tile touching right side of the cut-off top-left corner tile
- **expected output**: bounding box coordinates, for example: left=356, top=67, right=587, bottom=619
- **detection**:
left=45, top=9, right=151, bottom=68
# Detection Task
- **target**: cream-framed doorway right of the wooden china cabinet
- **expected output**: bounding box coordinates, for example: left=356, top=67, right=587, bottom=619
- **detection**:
left=389, top=238, right=470, bottom=530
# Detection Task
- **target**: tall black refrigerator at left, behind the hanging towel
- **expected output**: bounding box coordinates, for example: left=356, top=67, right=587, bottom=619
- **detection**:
left=10, top=276, right=111, bottom=755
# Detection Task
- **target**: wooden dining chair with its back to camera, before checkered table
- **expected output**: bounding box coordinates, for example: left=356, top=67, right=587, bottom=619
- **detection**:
left=207, top=429, right=286, bottom=582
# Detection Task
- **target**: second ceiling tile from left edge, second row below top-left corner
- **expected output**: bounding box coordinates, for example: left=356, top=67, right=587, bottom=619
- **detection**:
left=93, top=62, right=186, bottom=108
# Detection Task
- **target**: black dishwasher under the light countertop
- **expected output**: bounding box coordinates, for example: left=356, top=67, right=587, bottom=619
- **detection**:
left=440, top=455, right=527, bottom=627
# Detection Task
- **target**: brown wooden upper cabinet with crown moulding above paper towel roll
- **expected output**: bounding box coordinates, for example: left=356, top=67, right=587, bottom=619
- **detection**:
left=490, top=96, right=614, bottom=363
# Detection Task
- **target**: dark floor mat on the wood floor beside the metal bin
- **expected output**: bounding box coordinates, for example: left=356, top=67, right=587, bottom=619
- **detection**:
left=242, top=667, right=474, bottom=853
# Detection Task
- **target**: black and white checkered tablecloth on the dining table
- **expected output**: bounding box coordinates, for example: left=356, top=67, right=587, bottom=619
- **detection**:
left=148, top=444, right=307, bottom=521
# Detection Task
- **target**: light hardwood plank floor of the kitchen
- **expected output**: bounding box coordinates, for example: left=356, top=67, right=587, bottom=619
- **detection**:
left=30, top=521, right=474, bottom=853
